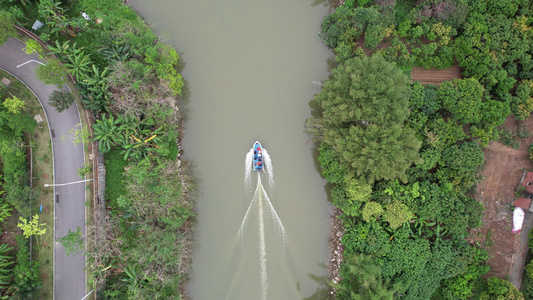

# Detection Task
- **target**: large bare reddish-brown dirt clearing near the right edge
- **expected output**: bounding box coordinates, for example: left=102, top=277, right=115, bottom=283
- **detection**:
left=471, top=116, right=533, bottom=279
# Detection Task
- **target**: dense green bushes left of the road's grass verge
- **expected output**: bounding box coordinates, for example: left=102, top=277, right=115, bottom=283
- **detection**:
left=0, top=68, right=45, bottom=299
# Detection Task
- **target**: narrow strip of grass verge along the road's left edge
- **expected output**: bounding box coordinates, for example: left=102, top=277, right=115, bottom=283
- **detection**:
left=0, top=70, right=54, bottom=299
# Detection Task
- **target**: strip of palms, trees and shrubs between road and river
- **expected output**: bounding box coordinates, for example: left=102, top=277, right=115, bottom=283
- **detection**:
left=0, top=0, right=194, bottom=299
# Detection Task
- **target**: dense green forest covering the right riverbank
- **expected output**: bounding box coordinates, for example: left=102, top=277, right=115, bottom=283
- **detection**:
left=307, top=0, right=533, bottom=299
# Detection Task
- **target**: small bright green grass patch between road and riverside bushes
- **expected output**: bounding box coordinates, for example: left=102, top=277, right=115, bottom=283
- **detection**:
left=105, top=149, right=128, bottom=208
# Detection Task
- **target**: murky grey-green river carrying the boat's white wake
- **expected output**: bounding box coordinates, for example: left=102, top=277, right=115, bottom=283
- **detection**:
left=129, top=0, right=331, bottom=300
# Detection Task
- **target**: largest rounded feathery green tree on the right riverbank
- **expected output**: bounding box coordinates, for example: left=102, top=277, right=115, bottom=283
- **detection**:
left=310, top=55, right=421, bottom=183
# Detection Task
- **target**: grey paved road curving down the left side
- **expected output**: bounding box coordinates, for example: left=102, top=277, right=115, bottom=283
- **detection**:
left=0, top=38, right=86, bottom=300
